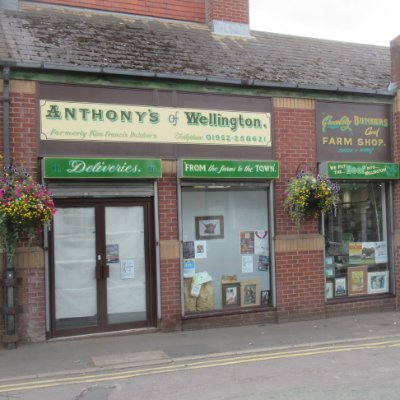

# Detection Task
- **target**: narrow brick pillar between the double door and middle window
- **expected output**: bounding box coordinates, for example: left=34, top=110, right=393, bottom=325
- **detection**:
left=158, top=161, right=181, bottom=331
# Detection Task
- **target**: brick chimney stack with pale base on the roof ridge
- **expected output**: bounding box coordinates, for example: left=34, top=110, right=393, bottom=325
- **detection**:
left=206, top=0, right=250, bottom=36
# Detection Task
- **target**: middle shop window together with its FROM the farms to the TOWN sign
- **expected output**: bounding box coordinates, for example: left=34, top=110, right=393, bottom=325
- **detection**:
left=178, top=159, right=279, bottom=318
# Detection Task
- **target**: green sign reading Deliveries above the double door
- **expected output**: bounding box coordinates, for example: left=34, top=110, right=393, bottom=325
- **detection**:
left=44, top=157, right=162, bottom=179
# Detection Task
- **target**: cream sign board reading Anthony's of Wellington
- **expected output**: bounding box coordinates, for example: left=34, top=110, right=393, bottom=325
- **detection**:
left=40, top=100, right=271, bottom=147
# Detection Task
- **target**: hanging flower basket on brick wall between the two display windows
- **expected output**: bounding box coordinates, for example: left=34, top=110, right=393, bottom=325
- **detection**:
left=284, top=172, right=339, bottom=227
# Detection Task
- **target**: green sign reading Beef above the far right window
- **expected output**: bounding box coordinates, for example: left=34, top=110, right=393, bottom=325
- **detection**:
left=327, top=162, right=399, bottom=179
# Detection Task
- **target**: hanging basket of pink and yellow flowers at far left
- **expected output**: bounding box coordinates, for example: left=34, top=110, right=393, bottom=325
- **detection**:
left=0, top=165, right=55, bottom=262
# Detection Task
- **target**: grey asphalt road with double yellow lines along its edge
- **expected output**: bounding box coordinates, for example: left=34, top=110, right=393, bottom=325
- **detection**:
left=0, top=337, right=400, bottom=400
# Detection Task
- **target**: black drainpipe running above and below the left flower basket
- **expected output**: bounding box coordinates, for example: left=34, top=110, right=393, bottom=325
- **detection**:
left=3, top=66, right=18, bottom=348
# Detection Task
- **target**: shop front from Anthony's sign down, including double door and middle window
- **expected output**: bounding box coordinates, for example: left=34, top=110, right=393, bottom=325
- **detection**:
left=38, top=84, right=279, bottom=337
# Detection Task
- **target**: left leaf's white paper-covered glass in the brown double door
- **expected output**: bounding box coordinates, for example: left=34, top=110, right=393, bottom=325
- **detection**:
left=54, top=207, right=98, bottom=330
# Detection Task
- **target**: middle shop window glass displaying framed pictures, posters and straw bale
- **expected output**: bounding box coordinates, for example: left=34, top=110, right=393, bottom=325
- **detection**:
left=181, top=184, right=271, bottom=314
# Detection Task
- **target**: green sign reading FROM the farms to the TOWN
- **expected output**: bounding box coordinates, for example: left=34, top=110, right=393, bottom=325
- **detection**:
left=182, top=160, right=279, bottom=179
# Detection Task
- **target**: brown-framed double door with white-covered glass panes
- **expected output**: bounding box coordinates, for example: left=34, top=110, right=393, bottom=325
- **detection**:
left=51, top=199, right=156, bottom=336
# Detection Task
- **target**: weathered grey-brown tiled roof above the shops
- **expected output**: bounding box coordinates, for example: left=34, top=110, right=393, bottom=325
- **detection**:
left=0, top=7, right=390, bottom=90
